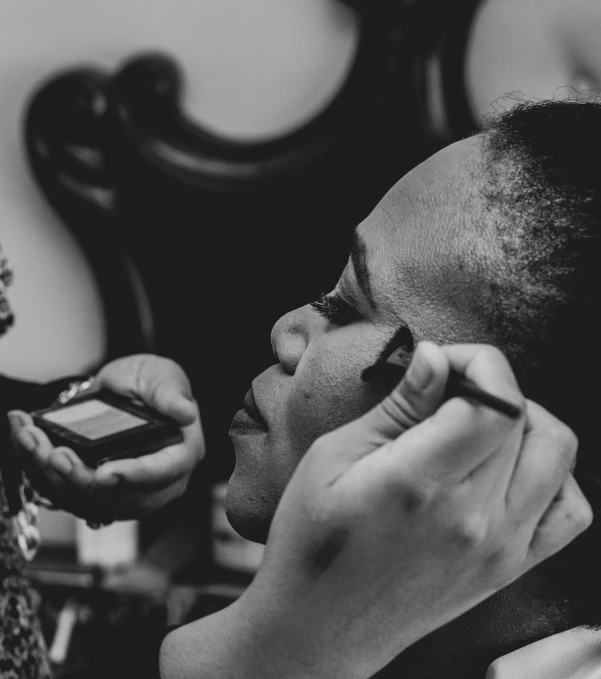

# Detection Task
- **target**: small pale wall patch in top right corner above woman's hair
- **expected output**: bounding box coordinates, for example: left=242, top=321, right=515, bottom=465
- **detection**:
left=466, top=0, right=601, bottom=122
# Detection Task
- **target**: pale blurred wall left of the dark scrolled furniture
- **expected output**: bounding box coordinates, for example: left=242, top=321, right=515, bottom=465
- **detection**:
left=0, top=0, right=357, bottom=380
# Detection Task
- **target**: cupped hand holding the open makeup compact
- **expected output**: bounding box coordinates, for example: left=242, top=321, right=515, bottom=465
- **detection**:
left=10, top=355, right=204, bottom=521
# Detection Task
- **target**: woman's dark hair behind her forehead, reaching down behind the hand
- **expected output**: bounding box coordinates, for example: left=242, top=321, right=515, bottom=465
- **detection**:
left=478, top=100, right=601, bottom=627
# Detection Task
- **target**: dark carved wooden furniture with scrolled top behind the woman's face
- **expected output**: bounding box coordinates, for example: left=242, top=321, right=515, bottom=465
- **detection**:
left=23, top=0, right=478, bottom=564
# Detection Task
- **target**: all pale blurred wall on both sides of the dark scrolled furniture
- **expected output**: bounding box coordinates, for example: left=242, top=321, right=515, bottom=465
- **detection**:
left=0, top=0, right=601, bottom=380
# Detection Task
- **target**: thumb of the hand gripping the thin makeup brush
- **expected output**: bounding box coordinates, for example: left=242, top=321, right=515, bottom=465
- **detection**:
left=340, top=342, right=450, bottom=459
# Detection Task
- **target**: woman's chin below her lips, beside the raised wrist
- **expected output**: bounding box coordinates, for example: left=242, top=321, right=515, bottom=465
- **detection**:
left=225, top=470, right=277, bottom=545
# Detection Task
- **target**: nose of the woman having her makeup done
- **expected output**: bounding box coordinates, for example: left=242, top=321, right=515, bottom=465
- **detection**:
left=271, top=304, right=319, bottom=375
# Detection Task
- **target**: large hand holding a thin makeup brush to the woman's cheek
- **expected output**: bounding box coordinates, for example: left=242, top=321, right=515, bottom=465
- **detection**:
left=219, top=343, right=592, bottom=677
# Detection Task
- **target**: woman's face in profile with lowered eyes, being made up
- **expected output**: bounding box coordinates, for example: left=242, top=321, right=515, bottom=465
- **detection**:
left=227, top=137, right=492, bottom=541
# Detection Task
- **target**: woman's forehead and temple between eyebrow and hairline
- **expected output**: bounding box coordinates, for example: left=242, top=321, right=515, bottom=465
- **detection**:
left=358, top=137, right=483, bottom=341
